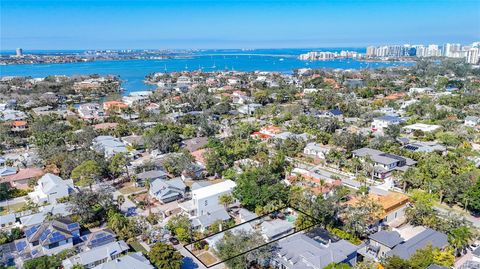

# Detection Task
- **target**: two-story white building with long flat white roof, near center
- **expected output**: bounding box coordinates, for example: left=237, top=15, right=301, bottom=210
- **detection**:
left=179, top=180, right=236, bottom=218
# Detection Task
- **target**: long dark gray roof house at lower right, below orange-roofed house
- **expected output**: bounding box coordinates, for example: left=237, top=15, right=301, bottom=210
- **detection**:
left=386, top=228, right=448, bottom=259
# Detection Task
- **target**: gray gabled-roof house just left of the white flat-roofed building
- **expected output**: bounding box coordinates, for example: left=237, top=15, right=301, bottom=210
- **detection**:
left=148, top=178, right=187, bottom=203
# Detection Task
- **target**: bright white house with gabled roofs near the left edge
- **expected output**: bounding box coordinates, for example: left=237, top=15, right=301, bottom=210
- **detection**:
left=28, top=173, right=75, bottom=204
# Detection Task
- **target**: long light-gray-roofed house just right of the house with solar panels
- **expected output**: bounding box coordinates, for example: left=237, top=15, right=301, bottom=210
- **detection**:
left=62, top=240, right=130, bottom=269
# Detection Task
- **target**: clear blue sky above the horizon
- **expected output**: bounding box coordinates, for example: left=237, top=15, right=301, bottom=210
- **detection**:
left=0, top=0, right=480, bottom=50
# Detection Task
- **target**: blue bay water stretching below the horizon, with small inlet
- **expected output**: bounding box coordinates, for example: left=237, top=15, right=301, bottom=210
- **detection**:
left=0, top=49, right=413, bottom=94
